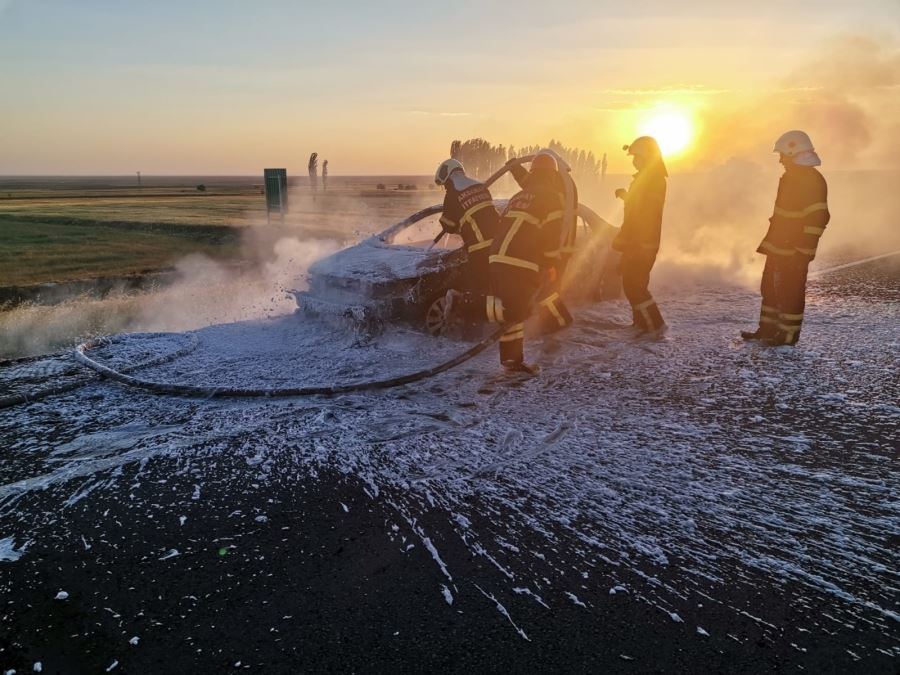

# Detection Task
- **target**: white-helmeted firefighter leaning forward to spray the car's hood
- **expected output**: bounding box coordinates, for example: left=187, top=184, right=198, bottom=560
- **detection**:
left=434, top=159, right=500, bottom=320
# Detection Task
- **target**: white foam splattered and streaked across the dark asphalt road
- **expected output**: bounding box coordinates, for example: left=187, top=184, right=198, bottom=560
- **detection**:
left=0, top=282, right=900, bottom=656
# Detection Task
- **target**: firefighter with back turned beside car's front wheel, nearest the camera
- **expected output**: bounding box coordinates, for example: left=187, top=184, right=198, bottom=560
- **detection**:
left=486, top=154, right=564, bottom=373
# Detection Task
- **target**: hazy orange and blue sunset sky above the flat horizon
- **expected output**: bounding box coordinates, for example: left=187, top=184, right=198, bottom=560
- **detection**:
left=0, top=0, right=900, bottom=175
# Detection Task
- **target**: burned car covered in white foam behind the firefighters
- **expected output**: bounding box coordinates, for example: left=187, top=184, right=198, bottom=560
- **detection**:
left=294, top=199, right=621, bottom=334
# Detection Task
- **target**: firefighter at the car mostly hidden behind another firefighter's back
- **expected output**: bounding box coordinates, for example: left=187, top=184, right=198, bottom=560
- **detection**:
left=506, top=148, right=578, bottom=334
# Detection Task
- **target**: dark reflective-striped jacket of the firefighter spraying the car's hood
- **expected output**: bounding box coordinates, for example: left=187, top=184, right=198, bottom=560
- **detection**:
left=441, top=172, right=500, bottom=256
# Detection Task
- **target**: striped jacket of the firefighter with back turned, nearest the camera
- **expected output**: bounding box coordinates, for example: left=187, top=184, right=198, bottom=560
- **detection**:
left=490, top=177, right=563, bottom=277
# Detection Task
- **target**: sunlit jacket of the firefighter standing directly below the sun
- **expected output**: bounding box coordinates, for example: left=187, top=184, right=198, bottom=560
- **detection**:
left=612, top=167, right=666, bottom=256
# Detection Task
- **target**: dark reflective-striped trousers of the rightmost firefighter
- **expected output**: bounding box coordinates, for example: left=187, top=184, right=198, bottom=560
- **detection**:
left=759, top=254, right=809, bottom=344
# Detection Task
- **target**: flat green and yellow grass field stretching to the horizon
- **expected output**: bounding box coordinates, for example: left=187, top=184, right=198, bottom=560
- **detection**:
left=0, top=177, right=440, bottom=288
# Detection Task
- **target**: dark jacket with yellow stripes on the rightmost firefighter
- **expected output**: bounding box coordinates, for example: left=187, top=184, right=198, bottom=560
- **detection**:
left=756, top=166, right=831, bottom=261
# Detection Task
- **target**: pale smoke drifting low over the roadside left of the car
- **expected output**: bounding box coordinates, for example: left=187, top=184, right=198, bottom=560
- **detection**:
left=0, top=188, right=440, bottom=358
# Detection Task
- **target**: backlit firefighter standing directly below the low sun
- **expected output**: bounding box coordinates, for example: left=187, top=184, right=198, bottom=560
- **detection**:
left=612, top=136, right=669, bottom=334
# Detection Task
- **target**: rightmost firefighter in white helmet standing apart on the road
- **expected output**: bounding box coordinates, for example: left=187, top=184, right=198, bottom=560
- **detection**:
left=741, top=130, right=831, bottom=346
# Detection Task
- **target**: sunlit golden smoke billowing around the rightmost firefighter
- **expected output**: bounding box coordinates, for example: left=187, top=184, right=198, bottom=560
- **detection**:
left=589, top=36, right=900, bottom=290
